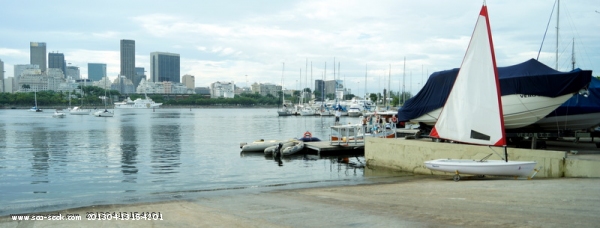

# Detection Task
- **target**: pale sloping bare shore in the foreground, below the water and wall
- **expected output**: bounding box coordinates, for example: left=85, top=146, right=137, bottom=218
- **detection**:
left=0, top=176, right=600, bottom=227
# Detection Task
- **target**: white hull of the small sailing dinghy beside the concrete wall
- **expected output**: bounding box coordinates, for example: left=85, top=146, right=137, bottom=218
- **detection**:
left=425, top=159, right=537, bottom=176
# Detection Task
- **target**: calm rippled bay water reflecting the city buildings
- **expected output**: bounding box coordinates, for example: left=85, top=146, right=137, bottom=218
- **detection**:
left=0, top=109, right=408, bottom=215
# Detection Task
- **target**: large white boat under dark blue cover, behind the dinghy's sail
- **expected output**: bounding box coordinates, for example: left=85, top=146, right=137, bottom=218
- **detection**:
left=398, top=59, right=592, bottom=129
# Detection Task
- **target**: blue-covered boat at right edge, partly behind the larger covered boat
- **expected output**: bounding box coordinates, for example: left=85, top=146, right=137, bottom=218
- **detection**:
left=535, top=77, right=600, bottom=131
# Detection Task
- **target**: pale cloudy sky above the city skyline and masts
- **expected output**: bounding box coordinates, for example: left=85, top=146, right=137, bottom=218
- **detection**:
left=0, top=0, right=600, bottom=94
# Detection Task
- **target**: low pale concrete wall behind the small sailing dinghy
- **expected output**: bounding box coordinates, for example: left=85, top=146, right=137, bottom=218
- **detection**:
left=365, top=138, right=600, bottom=177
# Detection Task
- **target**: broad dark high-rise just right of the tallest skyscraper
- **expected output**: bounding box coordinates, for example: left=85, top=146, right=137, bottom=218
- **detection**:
left=150, top=52, right=181, bottom=83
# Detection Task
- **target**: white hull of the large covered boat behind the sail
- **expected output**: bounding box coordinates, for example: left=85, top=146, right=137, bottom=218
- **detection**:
left=410, top=94, right=573, bottom=129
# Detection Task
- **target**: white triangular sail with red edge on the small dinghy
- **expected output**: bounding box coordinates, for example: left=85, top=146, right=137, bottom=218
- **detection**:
left=431, top=5, right=506, bottom=146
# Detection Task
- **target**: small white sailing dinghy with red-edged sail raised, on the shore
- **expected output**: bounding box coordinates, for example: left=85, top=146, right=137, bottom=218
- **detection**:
left=425, top=5, right=537, bottom=181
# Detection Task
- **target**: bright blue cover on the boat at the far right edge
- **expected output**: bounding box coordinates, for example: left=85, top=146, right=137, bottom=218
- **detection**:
left=548, top=77, right=600, bottom=118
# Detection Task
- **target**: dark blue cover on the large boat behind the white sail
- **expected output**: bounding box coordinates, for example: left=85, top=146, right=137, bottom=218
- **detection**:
left=398, top=59, right=592, bottom=122
